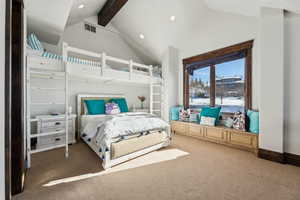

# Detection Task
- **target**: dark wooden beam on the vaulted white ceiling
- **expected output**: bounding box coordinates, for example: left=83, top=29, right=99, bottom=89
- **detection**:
left=98, top=0, right=128, bottom=26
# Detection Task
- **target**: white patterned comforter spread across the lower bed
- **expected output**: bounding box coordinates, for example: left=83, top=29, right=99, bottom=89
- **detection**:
left=82, top=112, right=169, bottom=143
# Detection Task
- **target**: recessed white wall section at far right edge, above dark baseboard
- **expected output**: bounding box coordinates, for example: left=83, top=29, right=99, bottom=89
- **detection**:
left=284, top=12, right=300, bottom=155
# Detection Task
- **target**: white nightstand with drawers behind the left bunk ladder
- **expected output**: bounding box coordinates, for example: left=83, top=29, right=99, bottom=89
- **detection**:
left=36, top=114, right=76, bottom=149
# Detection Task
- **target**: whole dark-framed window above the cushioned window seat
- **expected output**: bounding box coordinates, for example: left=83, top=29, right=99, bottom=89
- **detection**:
left=183, top=41, right=253, bottom=113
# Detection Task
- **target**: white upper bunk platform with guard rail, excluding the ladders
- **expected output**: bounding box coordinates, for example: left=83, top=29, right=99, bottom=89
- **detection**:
left=27, top=43, right=162, bottom=84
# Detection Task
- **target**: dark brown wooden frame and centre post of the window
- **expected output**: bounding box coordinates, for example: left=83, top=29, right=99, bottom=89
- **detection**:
left=183, top=40, right=254, bottom=110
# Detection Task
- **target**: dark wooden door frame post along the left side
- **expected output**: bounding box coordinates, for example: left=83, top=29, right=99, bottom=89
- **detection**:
left=4, top=0, right=25, bottom=200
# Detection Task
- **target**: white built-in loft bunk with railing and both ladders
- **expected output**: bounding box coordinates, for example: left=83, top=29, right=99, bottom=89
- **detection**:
left=26, top=43, right=164, bottom=167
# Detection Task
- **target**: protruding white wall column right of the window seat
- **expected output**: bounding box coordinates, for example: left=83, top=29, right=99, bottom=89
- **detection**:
left=259, top=8, right=284, bottom=153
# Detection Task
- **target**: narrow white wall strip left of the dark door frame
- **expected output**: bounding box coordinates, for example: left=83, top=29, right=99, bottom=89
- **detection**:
left=0, top=1, right=5, bottom=199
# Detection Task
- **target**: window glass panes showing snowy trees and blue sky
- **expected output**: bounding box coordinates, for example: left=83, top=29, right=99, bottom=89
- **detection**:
left=189, top=58, right=245, bottom=112
